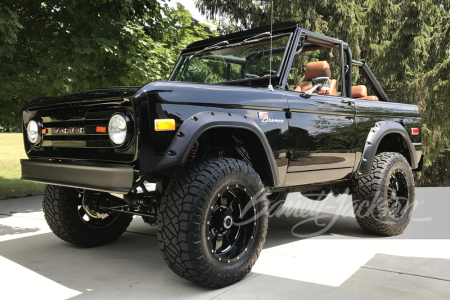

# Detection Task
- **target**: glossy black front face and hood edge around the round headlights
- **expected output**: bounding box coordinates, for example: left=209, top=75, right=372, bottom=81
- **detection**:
left=23, top=87, right=137, bottom=162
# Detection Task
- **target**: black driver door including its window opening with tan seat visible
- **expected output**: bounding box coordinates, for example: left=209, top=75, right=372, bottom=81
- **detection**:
left=284, top=41, right=356, bottom=186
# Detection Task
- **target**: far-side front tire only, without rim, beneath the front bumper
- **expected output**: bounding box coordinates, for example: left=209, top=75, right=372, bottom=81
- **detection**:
left=42, top=185, right=133, bottom=247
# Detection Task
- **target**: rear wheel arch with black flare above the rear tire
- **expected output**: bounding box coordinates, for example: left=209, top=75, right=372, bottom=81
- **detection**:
left=355, top=121, right=419, bottom=178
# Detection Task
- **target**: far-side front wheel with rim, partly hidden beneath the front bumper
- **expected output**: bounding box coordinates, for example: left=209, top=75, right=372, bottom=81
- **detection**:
left=43, top=185, right=133, bottom=247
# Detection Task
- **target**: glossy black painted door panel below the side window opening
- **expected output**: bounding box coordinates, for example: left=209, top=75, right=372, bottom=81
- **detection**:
left=285, top=92, right=356, bottom=186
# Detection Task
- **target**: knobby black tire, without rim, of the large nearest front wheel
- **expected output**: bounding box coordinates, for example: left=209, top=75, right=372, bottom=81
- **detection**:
left=158, top=158, right=267, bottom=288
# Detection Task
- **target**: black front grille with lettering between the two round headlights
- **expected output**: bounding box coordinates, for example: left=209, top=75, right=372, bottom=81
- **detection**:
left=29, top=106, right=135, bottom=162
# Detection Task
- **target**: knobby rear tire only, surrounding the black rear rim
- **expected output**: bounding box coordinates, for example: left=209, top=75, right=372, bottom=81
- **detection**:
left=353, top=152, right=415, bottom=236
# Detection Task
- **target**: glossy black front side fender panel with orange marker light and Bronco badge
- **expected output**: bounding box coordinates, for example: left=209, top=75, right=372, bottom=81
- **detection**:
left=138, top=81, right=288, bottom=183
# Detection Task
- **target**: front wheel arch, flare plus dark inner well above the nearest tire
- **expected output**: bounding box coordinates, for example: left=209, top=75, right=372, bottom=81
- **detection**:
left=153, top=111, right=280, bottom=186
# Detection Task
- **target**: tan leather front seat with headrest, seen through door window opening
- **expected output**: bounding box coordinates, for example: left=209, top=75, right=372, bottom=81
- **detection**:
left=294, top=61, right=337, bottom=96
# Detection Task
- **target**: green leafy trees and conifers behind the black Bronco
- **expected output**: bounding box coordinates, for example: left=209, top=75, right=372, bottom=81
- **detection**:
left=0, top=0, right=450, bottom=186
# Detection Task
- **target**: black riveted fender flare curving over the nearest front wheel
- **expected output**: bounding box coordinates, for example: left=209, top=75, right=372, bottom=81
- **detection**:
left=153, top=111, right=280, bottom=186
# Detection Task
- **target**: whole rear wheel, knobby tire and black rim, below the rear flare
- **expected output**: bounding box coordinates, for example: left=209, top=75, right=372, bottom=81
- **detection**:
left=353, top=152, right=414, bottom=236
